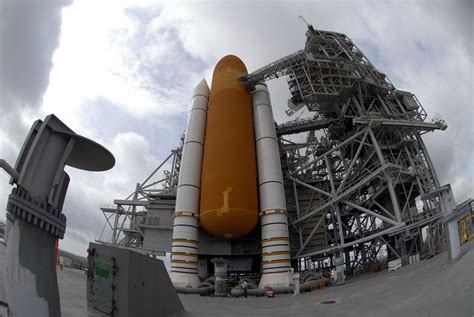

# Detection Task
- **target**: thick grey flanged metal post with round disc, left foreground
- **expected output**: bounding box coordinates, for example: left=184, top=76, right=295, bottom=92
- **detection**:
left=0, top=114, right=115, bottom=316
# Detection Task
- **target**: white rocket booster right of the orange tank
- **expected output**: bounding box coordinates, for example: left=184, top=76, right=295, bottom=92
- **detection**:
left=252, top=84, right=291, bottom=288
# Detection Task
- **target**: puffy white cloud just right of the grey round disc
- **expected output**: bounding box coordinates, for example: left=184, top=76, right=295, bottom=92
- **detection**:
left=62, top=132, right=161, bottom=253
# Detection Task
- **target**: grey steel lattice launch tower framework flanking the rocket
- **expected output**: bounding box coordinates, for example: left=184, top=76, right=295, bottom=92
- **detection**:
left=97, top=25, right=459, bottom=282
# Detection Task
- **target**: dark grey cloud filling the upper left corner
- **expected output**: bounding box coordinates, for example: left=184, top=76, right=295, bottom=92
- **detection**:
left=0, top=0, right=72, bottom=215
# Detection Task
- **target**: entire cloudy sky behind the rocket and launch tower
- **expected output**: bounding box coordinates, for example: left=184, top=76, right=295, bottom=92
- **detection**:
left=0, top=0, right=474, bottom=255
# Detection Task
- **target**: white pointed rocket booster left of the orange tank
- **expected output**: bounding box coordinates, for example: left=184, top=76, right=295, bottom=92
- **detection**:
left=170, top=80, right=209, bottom=287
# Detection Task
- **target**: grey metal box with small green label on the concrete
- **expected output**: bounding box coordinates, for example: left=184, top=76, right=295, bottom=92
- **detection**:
left=87, top=243, right=184, bottom=316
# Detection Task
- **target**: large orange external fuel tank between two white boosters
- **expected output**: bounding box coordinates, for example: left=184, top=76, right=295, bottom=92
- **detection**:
left=199, top=55, right=258, bottom=238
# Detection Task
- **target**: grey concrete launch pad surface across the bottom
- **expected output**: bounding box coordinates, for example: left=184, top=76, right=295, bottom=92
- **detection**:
left=0, top=241, right=474, bottom=317
